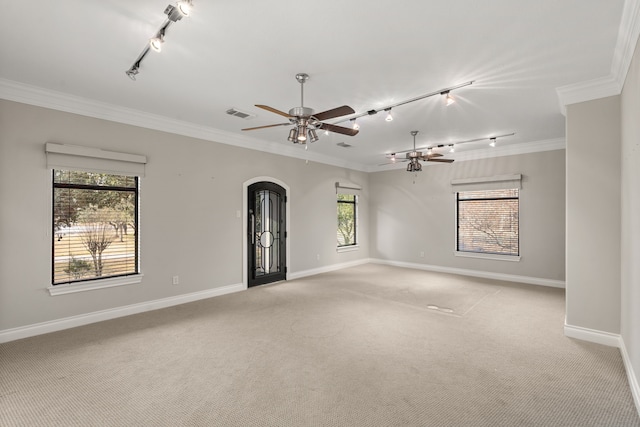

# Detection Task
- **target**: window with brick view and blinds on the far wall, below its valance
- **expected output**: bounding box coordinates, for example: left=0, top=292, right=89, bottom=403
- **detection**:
left=456, top=188, right=520, bottom=256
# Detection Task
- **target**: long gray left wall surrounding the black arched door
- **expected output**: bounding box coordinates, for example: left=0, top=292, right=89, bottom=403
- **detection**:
left=0, top=101, right=369, bottom=331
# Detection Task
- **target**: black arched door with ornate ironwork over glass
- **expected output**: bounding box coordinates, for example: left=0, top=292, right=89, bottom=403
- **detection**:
left=248, top=182, right=286, bottom=286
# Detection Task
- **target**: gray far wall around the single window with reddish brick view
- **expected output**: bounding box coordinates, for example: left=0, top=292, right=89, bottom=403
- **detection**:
left=369, top=150, right=565, bottom=281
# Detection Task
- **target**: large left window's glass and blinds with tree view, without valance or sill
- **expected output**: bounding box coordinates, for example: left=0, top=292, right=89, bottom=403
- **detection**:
left=51, top=169, right=138, bottom=285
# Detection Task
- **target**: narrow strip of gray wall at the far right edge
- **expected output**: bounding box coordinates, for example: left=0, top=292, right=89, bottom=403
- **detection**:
left=620, top=36, right=640, bottom=399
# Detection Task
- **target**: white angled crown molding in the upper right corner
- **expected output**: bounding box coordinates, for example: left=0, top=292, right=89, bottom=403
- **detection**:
left=556, top=0, right=640, bottom=116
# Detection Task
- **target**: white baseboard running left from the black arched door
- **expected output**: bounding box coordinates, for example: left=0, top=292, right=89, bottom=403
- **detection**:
left=0, top=283, right=245, bottom=343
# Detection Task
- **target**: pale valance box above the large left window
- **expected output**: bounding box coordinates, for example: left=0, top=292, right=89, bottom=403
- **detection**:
left=45, top=142, right=147, bottom=176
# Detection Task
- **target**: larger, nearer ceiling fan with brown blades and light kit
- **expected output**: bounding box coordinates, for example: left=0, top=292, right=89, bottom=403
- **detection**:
left=242, top=73, right=358, bottom=144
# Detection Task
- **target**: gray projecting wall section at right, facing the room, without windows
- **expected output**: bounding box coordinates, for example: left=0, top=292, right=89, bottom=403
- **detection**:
left=566, top=96, right=620, bottom=334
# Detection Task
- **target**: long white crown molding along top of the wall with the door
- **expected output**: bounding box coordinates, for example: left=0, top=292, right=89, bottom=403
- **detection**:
left=0, top=79, right=367, bottom=172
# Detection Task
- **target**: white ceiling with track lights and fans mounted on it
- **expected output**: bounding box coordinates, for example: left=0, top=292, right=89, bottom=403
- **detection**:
left=0, top=0, right=624, bottom=170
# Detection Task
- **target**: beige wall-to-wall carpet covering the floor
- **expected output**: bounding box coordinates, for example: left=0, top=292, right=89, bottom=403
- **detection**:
left=0, top=265, right=640, bottom=427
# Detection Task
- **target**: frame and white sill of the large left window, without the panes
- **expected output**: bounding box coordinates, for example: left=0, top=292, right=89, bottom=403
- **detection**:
left=47, top=167, right=143, bottom=296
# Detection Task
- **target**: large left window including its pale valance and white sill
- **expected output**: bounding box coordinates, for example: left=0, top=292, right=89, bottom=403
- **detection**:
left=45, top=142, right=147, bottom=295
